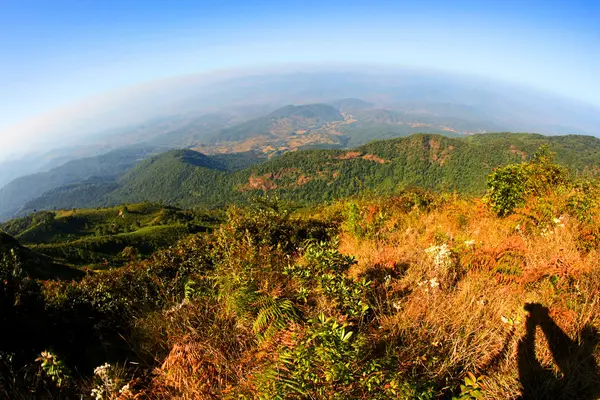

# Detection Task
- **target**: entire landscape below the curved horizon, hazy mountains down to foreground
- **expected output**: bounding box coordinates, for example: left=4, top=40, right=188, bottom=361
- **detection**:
left=0, top=74, right=600, bottom=400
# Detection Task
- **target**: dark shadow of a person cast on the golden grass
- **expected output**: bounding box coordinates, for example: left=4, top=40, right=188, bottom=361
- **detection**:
left=517, top=303, right=600, bottom=400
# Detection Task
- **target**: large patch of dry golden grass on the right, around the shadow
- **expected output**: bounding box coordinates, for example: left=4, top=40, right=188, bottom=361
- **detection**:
left=340, top=195, right=600, bottom=399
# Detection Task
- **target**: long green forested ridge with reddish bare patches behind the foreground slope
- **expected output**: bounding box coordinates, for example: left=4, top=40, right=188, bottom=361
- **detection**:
left=17, top=133, right=600, bottom=216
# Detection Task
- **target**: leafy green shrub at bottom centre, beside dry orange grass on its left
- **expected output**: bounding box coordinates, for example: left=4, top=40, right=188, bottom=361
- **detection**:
left=260, top=313, right=433, bottom=399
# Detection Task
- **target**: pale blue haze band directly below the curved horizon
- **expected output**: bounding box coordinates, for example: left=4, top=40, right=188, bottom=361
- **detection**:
left=0, top=66, right=600, bottom=159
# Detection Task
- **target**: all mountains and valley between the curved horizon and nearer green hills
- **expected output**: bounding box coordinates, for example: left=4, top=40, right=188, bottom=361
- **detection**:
left=0, top=71, right=600, bottom=220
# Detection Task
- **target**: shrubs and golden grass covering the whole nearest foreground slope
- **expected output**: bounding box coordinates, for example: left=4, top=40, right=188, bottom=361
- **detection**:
left=0, top=151, right=600, bottom=399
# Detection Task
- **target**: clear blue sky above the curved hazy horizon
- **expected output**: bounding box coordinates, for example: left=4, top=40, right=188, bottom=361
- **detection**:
left=0, top=0, right=600, bottom=148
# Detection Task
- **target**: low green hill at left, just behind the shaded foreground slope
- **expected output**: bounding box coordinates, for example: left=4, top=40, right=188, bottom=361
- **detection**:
left=0, top=202, right=218, bottom=265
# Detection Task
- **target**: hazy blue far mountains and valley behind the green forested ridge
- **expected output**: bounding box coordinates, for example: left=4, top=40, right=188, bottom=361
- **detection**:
left=0, top=67, right=600, bottom=186
